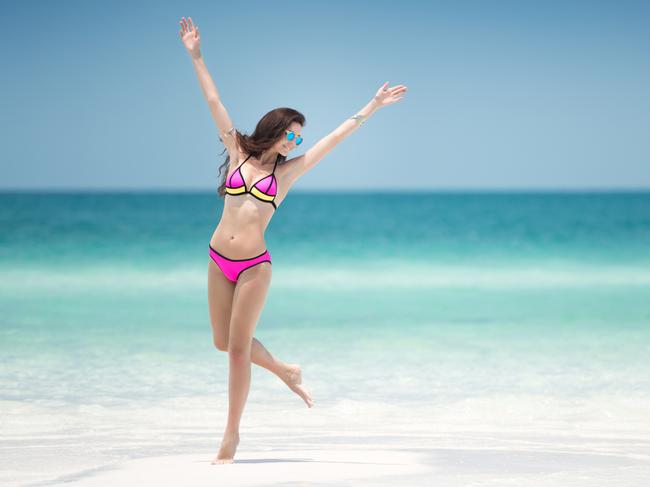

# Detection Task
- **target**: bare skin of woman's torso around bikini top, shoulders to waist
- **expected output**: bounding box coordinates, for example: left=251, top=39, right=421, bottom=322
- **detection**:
left=210, top=153, right=286, bottom=259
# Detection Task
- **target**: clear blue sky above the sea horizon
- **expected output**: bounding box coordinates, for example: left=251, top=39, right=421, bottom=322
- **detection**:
left=0, top=0, right=650, bottom=191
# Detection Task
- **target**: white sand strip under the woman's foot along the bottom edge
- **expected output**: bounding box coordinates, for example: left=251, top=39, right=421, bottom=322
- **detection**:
left=55, top=445, right=650, bottom=487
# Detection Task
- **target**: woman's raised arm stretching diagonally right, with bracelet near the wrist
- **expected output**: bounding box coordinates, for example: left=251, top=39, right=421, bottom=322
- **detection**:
left=287, top=82, right=406, bottom=184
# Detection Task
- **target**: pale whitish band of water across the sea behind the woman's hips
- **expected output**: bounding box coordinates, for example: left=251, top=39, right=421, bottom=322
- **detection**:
left=0, top=261, right=650, bottom=295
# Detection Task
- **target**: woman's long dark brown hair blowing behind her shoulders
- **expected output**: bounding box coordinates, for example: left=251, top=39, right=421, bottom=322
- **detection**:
left=217, top=108, right=305, bottom=197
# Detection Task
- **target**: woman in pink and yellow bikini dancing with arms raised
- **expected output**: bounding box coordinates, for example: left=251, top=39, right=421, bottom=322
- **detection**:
left=180, top=17, right=406, bottom=464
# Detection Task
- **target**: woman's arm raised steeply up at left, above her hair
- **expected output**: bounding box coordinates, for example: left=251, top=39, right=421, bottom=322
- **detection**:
left=180, top=17, right=238, bottom=161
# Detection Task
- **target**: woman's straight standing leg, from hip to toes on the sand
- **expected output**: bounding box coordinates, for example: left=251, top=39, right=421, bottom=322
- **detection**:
left=212, top=262, right=271, bottom=463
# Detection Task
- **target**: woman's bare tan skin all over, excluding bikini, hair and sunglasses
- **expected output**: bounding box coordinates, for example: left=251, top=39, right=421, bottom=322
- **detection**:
left=179, top=17, right=406, bottom=464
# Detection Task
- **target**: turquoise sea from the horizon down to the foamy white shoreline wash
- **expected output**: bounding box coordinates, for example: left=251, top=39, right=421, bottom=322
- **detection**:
left=0, top=192, right=650, bottom=483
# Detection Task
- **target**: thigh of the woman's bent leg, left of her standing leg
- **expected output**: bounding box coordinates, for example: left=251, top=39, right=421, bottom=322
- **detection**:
left=208, top=257, right=235, bottom=351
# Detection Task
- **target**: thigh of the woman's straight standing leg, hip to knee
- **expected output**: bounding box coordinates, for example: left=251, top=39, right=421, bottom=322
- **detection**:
left=229, top=262, right=271, bottom=350
